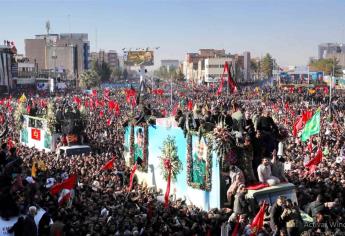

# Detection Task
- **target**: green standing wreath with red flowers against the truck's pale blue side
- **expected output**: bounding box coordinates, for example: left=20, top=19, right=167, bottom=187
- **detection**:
left=160, top=135, right=182, bottom=181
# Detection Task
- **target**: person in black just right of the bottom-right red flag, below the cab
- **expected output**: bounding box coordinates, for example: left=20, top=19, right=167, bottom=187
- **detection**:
left=270, top=196, right=285, bottom=236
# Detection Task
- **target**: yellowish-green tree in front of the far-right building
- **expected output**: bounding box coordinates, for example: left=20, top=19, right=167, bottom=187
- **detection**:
left=309, top=58, right=343, bottom=77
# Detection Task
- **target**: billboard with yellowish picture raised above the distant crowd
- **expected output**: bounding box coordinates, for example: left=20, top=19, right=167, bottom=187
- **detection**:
left=124, top=51, right=153, bottom=66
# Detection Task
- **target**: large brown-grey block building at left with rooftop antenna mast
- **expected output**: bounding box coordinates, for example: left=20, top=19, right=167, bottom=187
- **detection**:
left=25, top=33, right=90, bottom=79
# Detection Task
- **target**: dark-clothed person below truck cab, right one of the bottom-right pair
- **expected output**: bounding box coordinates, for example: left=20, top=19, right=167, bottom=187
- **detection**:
left=281, top=199, right=301, bottom=236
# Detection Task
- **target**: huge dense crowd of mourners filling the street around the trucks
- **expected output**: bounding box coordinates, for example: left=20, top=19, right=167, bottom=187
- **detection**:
left=0, top=84, right=345, bottom=236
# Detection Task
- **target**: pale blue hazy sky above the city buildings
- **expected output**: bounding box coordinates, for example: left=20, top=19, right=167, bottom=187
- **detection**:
left=0, top=0, right=345, bottom=65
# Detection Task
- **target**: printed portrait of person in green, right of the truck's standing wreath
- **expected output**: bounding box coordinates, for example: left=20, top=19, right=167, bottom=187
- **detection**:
left=192, top=141, right=206, bottom=185
